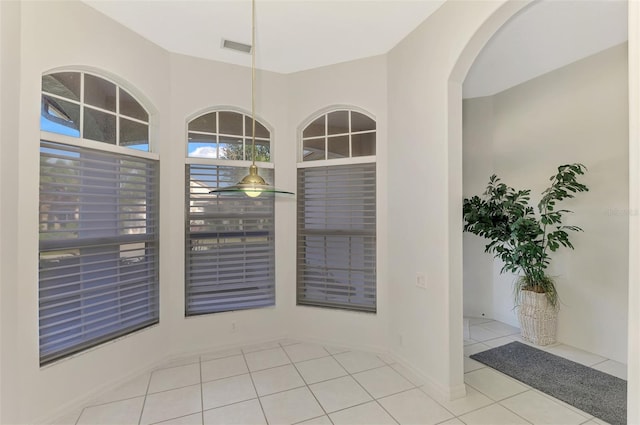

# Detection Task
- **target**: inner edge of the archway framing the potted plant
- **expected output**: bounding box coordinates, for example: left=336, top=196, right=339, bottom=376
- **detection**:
left=447, top=1, right=640, bottom=423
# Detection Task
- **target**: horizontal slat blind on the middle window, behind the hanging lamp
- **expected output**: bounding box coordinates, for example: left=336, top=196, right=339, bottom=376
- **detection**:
left=186, top=164, right=275, bottom=316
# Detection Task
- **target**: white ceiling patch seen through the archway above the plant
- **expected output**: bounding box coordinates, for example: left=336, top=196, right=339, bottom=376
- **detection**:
left=463, top=0, right=628, bottom=98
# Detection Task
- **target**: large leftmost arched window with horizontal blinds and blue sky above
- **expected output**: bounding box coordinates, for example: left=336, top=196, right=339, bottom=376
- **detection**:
left=39, top=71, right=159, bottom=364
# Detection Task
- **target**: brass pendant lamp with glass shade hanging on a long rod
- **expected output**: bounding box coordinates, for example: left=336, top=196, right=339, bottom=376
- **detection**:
left=209, top=0, right=294, bottom=198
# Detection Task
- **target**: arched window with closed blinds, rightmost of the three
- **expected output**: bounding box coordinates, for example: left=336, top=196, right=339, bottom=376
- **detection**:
left=297, top=109, right=376, bottom=312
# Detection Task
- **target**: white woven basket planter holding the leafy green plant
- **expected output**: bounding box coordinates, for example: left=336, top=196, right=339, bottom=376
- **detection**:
left=518, top=291, right=558, bottom=345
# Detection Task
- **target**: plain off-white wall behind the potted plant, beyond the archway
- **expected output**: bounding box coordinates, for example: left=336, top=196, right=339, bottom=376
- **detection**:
left=464, top=43, right=630, bottom=363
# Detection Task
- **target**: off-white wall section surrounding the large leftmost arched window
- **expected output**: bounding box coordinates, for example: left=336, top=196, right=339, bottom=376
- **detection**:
left=14, top=1, right=174, bottom=423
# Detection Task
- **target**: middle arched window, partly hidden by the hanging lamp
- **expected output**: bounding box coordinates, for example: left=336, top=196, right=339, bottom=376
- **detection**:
left=185, top=110, right=275, bottom=316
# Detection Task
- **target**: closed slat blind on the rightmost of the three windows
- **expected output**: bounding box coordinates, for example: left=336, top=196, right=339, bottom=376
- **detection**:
left=297, top=163, right=376, bottom=312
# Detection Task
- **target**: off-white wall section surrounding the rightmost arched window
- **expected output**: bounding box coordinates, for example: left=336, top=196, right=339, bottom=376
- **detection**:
left=286, top=56, right=389, bottom=351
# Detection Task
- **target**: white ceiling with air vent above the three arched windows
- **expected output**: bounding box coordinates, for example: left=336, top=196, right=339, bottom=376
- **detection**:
left=84, top=0, right=444, bottom=73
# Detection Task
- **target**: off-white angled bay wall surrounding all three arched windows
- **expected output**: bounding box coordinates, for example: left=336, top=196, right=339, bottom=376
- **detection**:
left=6, top=1, right=387, bottom=423
